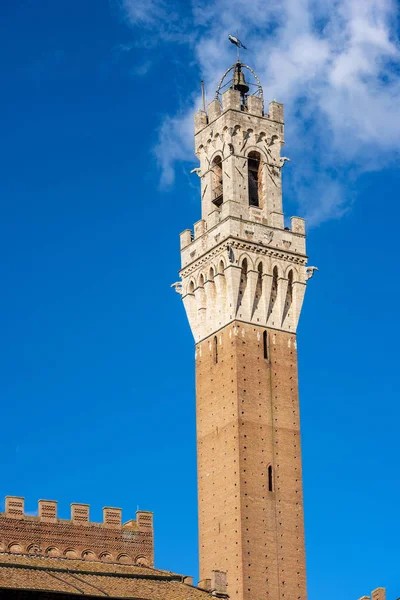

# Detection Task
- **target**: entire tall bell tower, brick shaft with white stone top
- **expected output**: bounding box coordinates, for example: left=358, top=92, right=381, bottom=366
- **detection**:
left=178, top=62, right=312, bottom=600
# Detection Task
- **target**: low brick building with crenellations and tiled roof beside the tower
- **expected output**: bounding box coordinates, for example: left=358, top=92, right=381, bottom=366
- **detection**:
left=0, top=496, right=227, bottom=600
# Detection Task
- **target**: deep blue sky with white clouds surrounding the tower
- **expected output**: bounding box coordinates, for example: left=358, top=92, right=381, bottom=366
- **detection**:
left=0, top=0, right=400, bottom=600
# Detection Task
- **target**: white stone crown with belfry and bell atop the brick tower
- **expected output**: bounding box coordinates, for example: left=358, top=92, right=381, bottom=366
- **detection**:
left=180, top=62, right=312, bottom=342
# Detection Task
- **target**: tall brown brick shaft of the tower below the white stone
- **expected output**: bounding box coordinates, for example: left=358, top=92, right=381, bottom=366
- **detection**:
left=196, top=322, right=306, bottom=600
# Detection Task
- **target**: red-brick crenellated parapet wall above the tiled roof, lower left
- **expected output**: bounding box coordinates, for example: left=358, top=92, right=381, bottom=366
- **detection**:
left=0, top=496, right=154, bottom=566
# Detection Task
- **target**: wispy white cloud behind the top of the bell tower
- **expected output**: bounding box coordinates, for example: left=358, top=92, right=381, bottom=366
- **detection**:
left=123, top=0, right=400, bottom=225
